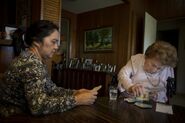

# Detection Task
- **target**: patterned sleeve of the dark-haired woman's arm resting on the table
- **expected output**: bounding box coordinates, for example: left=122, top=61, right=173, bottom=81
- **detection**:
left=24, top=64, right=76, bottom=115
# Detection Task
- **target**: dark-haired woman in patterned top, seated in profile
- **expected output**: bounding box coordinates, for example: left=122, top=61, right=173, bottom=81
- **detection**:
left=0, top=20, right=101, bottom=116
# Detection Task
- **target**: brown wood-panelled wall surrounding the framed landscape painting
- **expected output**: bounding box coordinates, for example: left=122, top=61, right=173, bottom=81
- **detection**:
left=76, top=4, right=130, bottom=71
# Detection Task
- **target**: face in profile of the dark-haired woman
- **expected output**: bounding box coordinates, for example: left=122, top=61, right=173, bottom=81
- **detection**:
left=38, top=30, right=59, bottom=59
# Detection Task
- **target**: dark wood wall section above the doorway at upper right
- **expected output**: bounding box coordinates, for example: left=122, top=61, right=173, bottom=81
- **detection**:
left=145, top=0, right=185, bottom=20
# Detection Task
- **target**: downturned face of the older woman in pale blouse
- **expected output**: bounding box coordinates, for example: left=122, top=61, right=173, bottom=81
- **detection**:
left=144, top=58, right=163, bottom=73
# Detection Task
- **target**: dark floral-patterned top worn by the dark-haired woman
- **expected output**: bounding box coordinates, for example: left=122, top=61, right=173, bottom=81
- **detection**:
left=0, top=51, right=75, bottom=116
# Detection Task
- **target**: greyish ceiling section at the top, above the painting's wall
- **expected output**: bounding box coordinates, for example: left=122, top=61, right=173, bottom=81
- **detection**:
left=62, top=0, right=124, bottom=14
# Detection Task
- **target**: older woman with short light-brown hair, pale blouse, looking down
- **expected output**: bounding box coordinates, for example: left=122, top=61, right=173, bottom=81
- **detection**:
left=118, top=41, right=177, bottom=102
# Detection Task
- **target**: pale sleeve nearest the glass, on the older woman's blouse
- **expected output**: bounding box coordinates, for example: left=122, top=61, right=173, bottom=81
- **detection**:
left=118, top=60, right=133, bottom=92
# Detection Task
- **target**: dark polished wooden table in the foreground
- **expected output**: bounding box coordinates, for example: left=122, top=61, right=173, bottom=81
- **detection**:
left=0, top=97, right=185, bottom=123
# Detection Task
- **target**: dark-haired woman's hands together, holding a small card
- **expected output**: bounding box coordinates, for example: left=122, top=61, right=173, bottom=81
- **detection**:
left=74, top=86, right=101, bottom=105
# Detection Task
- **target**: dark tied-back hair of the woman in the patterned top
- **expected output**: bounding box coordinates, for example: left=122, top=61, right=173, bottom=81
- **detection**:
left=12, top=20, right=58, bottom=56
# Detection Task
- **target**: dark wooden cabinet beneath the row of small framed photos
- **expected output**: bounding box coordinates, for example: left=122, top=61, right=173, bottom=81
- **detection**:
left=52, top=68, right=109, bottom=96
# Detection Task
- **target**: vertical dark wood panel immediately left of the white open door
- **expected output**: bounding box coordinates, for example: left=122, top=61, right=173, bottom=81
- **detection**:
left=129, top=0, right=146, bottom=56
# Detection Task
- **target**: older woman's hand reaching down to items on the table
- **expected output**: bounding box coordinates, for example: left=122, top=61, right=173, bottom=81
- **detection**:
left=128, top=83, right=145, bottom=96
